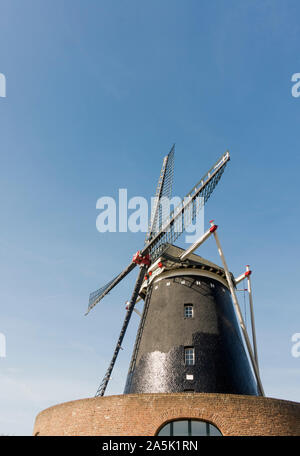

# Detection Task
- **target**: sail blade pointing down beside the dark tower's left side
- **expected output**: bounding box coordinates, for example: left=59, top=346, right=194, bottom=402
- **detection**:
left=96, top=266, right=147, bottom=397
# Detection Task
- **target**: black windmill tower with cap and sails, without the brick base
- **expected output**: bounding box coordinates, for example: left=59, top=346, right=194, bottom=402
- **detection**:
left=87, top=146, right=264, bottom=396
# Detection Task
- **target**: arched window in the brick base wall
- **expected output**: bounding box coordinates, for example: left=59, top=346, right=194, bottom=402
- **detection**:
left=157, top=420, right=222, bottom=437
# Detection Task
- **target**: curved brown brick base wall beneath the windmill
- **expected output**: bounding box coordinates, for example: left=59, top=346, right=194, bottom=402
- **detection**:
left=33, top=393, right=300, bottom=436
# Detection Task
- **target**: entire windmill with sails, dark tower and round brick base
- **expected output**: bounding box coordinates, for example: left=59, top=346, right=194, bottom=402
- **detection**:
left=35, top=146, right=300, bottom=436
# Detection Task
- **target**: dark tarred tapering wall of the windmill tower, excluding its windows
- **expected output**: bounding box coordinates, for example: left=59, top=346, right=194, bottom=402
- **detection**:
left=124, top=276, right=257, bottom=395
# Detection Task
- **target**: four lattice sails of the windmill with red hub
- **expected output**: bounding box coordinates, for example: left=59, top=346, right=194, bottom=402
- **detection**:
left=86, top=145, right=234, bottom=396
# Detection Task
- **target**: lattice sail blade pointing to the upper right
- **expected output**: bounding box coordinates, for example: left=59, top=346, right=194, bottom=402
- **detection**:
left=142, top=151, right=230, bottom=261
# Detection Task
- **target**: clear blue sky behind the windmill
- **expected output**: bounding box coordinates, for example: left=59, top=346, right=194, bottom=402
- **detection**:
left=0, top=0, right=300, bottom=435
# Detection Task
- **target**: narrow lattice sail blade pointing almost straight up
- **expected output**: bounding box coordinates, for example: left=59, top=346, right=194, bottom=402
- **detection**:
left=145, top=144, right=175, bottom=243
